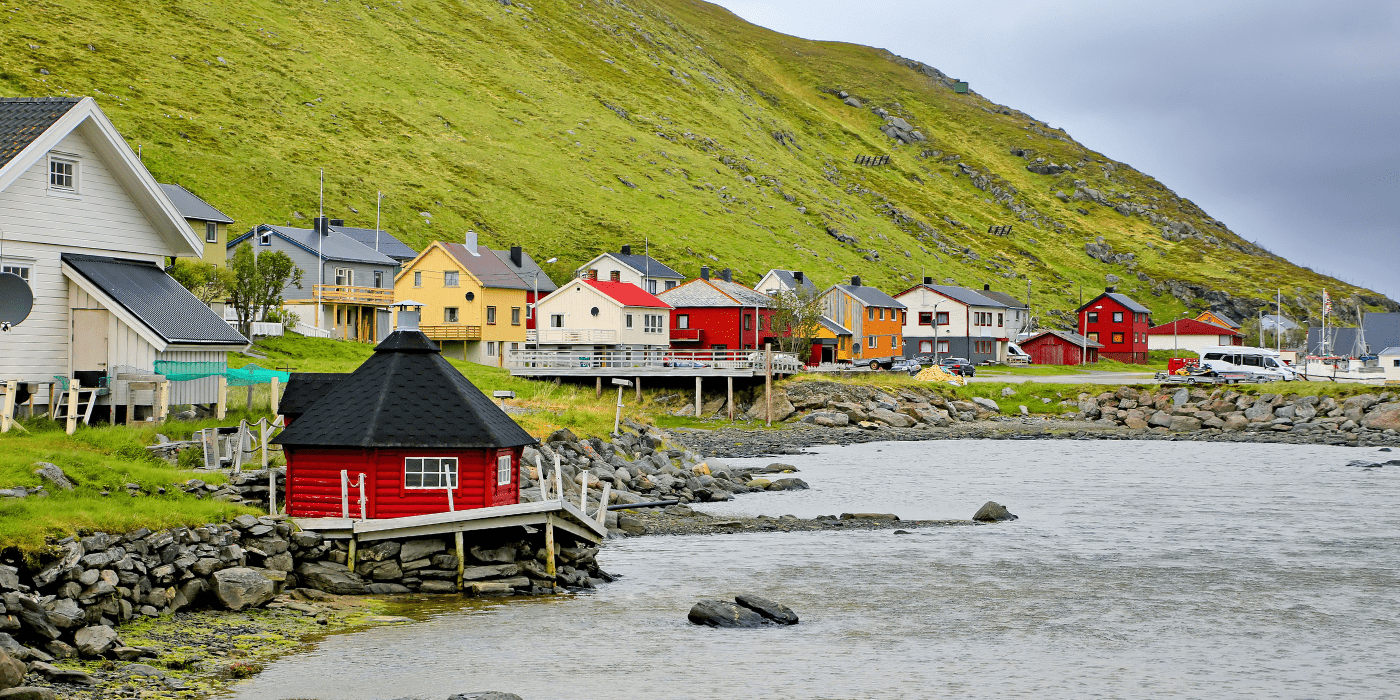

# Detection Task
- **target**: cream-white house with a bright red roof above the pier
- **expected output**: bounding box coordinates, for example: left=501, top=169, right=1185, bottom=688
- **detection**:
left=532, top=279, right=671, bottom=350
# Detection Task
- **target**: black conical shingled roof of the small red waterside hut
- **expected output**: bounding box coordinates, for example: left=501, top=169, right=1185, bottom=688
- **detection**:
left=273, top=330, right=536, bottom=449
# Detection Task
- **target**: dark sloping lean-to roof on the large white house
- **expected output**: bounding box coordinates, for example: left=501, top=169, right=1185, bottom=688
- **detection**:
left=62, top=253, right=248, bottom=346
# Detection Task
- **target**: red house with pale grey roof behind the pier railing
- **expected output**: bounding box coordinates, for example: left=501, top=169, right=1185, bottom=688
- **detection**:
left=657, top=267, right=774, bottom=350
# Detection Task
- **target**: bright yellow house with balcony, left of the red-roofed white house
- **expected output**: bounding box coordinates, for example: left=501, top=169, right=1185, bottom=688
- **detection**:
left=393, top=234, right=531, bottom=367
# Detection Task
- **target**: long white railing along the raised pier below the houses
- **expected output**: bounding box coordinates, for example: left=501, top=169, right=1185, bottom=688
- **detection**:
left=504, top=350, right=804, bottom=374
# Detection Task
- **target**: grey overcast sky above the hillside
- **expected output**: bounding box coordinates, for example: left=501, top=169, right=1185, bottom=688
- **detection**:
left=718, top=0, right=1400, bottom=300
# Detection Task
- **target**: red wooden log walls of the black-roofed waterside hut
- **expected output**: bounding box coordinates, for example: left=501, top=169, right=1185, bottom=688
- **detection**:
left=286, top=447, right=522, bottom=518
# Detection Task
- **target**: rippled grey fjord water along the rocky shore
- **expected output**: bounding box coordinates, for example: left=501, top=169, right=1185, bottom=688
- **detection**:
left=235, top=441, right=1400, bottom=700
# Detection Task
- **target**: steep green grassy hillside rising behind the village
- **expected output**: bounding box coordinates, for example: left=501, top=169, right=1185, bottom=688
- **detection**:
left=0, top=0, right=1383, bottom=325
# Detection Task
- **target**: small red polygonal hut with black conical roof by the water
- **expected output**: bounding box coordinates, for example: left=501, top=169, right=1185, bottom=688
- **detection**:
left=273, top=324, right=536, bottom=518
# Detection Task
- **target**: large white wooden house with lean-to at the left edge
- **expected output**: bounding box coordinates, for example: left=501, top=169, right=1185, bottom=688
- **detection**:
left=0, top=98, right=248, bottom=405
